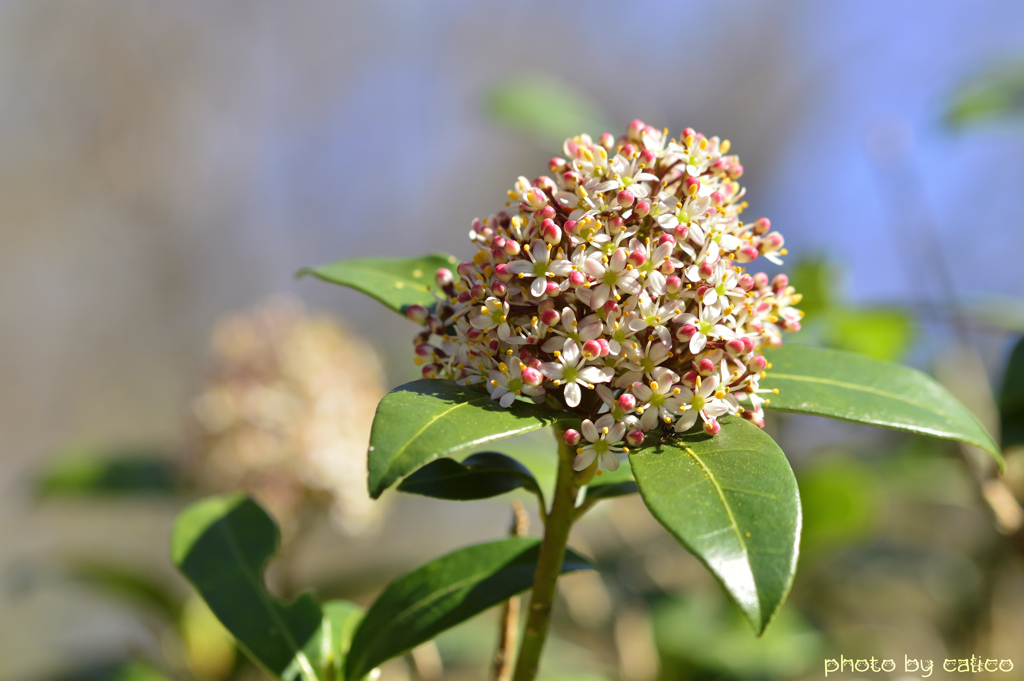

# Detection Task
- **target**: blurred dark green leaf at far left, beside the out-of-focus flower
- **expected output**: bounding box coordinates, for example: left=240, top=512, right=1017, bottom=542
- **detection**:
left=37, top=451, right=179, bottom=497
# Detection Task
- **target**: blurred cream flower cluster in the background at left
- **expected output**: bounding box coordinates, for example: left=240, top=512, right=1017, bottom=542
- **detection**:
left=191, top=299, right=386, bottom=538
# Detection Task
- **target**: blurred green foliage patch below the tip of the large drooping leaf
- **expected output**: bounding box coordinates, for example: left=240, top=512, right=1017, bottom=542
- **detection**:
left=652, top=596, right=822, bottom=679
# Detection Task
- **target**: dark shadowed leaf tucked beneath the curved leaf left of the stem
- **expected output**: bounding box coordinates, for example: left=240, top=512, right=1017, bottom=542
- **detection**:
left=398, top=452, right=543, bottom=501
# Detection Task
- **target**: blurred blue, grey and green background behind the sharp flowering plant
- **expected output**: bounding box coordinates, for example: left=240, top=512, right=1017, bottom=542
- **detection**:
left=6, top=0, right=1024, bottom=681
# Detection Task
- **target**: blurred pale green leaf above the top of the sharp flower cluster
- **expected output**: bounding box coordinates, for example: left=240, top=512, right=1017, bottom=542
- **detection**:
left=485, top=75, right=611, bottom=144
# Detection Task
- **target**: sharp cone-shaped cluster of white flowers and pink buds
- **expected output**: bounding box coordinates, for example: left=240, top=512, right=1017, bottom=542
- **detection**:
left=409, top=121, right=803, bottom=471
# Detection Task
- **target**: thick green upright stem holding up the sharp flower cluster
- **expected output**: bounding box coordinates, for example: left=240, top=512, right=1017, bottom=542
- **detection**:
left=512, top=428, right=582, bottom=681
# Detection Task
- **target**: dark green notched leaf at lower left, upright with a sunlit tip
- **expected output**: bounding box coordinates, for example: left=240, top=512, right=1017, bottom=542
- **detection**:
left=171, top=495, right=366, bottom=681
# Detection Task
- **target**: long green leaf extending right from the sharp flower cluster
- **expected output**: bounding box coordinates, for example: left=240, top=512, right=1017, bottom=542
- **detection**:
left=761, top=345, right=1002, bottom=470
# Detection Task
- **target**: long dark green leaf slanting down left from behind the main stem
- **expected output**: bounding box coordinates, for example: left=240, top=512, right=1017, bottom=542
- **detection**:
left=345, top=537, right=592, bottom=679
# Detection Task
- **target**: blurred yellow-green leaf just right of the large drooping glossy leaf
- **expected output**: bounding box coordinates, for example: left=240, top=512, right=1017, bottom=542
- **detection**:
left=797, top=458, right=879, bottom=554
